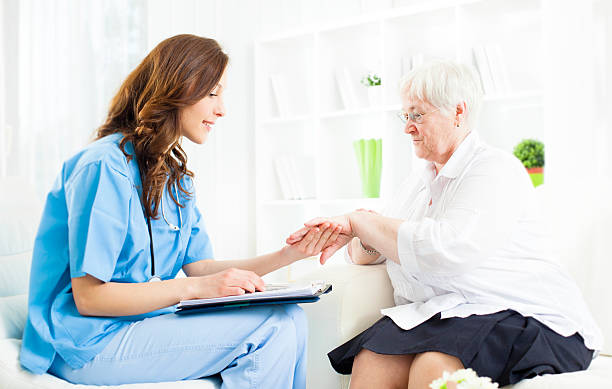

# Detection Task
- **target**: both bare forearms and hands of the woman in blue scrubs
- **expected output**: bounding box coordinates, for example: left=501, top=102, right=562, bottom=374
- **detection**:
left=72, top=224, right=340, bottom=316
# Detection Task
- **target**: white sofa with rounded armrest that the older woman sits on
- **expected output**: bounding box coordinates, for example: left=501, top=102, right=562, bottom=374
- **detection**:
left=302, top=180, right=612, bottom=389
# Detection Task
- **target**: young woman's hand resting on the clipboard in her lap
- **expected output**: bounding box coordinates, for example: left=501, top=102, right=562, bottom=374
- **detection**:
left=189, top=268, right=265, bottom=298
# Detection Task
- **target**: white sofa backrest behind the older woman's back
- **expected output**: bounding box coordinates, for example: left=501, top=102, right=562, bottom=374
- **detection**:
left=536, top=181, right=612, bottom=354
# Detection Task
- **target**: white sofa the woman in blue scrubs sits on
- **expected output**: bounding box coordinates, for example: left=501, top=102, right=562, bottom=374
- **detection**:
left=0, top=178, right=221, bottom=389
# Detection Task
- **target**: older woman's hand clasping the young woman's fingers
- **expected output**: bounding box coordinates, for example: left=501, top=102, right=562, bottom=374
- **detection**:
left=286, top=214, right=353, bottom=265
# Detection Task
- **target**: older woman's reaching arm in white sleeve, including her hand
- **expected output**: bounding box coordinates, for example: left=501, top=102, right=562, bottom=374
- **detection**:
left=288, top=156, right=537, bottom=276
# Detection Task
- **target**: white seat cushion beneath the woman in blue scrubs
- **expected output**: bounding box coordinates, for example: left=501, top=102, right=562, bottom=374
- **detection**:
left=0, top=339, right=221, bottom=389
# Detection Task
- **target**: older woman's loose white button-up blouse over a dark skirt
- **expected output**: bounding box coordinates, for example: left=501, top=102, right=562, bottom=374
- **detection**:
left=352, top=132, right=603, bottom=354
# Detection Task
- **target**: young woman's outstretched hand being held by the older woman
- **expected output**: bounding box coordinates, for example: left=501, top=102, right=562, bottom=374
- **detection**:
left=283, top=223, right=342, bottom=262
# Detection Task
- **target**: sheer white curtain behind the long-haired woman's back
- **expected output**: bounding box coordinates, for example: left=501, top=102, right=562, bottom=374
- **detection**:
left=0, top=0, right=147, bottom=195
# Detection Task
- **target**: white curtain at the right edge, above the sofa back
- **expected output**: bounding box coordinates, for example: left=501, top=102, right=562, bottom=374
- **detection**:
left=543, top=0, right=612, bottom=184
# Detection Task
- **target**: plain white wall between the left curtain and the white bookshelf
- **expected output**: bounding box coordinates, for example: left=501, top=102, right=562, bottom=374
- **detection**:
left=147, top=0, right=392, bottom=259
